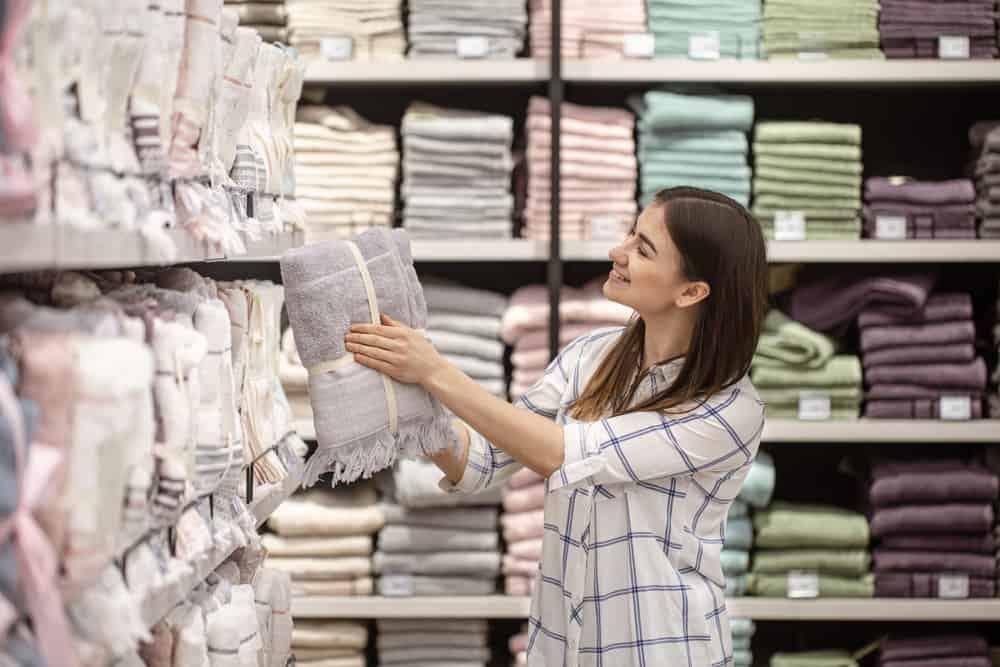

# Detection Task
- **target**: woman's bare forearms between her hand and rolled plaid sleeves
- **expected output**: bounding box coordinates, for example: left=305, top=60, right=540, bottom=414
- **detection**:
left=423, top=363, right=564, bottom=482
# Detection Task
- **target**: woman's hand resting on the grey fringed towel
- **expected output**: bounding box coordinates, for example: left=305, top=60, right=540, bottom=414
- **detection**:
left=344, top=313, right=447, bottom=384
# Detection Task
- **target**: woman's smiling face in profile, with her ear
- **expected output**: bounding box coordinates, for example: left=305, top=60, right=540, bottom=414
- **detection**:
left=603, top=202, right=708, bottom=321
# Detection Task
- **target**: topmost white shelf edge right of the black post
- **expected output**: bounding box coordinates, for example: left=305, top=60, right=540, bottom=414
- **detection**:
left=562, top=60, right=1000, bottom=87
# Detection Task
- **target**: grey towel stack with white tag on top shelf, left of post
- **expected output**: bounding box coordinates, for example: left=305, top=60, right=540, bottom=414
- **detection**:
left=407, top=0, right=528, bottom=58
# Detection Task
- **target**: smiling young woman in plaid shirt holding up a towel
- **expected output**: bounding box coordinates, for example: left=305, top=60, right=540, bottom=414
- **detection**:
left=347, top=188, right=767, bottom=667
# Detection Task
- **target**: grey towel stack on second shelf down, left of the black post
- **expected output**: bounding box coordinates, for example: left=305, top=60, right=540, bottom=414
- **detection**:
left=402, top=102, right=514, bottom=240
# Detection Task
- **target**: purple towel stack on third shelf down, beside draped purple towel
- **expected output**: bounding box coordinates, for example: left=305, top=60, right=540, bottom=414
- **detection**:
left=858, top=292, right=986, bottom=419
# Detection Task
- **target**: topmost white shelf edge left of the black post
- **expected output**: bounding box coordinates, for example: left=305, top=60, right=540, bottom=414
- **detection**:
left=306, top=58, right=549, bottom=86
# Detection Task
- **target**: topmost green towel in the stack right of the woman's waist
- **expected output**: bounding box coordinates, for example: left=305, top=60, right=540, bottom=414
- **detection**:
left=753, top=501, right=869, bottom=549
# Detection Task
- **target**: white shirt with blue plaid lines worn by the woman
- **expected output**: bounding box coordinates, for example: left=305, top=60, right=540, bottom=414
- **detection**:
left=446, top=328, right=764, bottom=667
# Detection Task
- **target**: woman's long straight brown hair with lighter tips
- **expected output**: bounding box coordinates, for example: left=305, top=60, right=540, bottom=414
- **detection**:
left=570, top=187, right=767, bottom=420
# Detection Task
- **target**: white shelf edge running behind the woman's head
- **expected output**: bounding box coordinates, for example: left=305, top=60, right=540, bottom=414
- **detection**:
left=562, top=239, right=1000, bottom=264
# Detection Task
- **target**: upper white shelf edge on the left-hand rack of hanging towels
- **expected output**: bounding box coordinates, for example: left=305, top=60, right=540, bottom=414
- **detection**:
left=0, top=223, right=303, bottom=273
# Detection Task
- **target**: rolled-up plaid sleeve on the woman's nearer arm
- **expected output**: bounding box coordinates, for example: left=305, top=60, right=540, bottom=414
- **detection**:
left=549, top=388, right=764, bottom=493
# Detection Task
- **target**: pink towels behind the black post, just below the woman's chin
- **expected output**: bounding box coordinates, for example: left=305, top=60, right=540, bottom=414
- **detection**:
left=500, top=279, right=632, bottom=399
